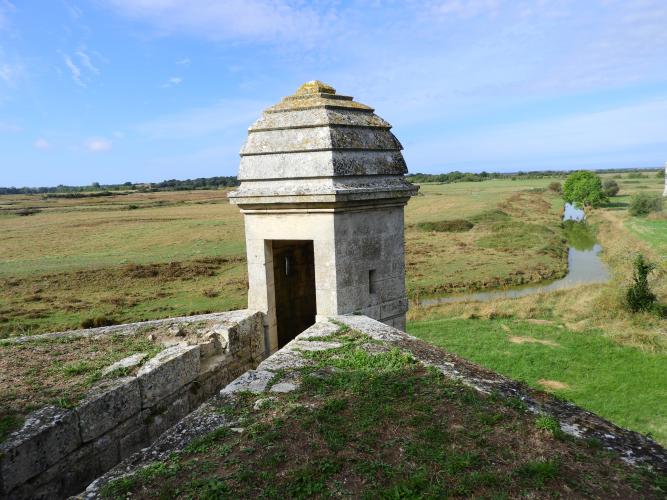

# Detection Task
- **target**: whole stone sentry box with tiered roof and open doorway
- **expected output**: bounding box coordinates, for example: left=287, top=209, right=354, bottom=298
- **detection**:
left=229, top=81, right=418, bottom=352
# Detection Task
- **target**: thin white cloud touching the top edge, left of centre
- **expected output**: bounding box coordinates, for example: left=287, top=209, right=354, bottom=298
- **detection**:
left=105, top=0, right=324, bottom=41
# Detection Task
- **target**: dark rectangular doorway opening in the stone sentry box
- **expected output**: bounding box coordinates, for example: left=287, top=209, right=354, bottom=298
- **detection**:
left=271, top=240, right=317, bottom=348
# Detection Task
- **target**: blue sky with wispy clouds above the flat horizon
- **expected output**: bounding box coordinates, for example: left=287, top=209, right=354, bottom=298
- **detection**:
left=0, top=0, right=667, bottom=186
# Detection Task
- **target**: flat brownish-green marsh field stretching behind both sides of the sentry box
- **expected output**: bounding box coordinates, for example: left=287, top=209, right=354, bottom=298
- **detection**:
left=0, top=180, right=566, bottom=338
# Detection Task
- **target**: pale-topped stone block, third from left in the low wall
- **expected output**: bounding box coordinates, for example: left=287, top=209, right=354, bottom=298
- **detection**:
left=137, top=345, right=200, bottom=408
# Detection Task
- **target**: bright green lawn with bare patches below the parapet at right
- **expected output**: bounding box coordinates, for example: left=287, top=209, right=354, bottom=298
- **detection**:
left=408, top=318, right=667, bottom=444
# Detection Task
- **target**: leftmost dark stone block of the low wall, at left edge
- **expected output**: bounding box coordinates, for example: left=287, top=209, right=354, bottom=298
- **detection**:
left=0, top=406, right=81, bottom=493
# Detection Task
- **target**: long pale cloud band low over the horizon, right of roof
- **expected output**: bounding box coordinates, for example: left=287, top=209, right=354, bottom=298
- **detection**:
left=409, top=100, right=667, bottom=169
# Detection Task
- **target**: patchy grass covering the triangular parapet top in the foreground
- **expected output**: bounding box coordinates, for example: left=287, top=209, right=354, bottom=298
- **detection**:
left=103, top=331, right=667, bottom=498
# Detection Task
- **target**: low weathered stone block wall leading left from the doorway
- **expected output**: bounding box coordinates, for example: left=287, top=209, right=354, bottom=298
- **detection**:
left=0, top=311, right=264, bottom=499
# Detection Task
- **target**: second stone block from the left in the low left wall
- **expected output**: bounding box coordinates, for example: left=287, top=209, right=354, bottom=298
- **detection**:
left=75, top=377, right=141, bottom=442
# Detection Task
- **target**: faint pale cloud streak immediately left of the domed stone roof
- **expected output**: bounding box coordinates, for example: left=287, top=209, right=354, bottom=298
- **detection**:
left=135, top=100, right=268, bottom=140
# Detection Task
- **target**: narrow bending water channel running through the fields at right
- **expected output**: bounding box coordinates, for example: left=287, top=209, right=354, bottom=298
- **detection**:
left=419, top=203, right=609, bottom=306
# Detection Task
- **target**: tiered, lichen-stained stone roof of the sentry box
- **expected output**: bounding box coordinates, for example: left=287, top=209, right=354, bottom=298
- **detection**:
left=230, top=80, right=416, bottom=204
